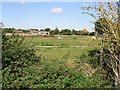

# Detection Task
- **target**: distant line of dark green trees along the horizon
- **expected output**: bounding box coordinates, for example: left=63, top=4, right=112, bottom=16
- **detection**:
left=4, top=28, right=95, bottom=36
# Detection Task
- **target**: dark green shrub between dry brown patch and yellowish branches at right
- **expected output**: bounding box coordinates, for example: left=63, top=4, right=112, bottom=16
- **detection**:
left=76, top=49, right=114, bottom=88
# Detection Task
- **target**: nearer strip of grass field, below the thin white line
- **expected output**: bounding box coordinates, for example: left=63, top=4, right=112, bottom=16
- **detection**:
left=36, top=47, right=93, bottom=59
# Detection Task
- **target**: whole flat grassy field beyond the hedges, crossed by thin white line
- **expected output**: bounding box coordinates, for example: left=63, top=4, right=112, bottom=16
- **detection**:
left=25, top=36, right=99, bottom=59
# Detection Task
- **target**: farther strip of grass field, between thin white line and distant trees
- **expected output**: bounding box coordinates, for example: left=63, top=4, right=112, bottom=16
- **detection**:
left=26, top=36, right=99, bottom=46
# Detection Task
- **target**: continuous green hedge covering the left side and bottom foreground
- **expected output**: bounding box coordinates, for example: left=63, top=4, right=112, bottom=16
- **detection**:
left=2, top=29, right=112, bottom=89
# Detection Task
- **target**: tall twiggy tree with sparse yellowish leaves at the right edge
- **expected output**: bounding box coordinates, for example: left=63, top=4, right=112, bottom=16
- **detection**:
left=81, top=1, right=120, bottom=86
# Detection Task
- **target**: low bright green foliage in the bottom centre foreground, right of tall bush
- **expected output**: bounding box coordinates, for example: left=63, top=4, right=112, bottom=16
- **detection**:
left=28, top=59, right=107, bottom=88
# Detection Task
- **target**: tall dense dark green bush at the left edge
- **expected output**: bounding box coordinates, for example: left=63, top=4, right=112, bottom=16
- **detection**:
left=2, top=32, right=40, bottom=89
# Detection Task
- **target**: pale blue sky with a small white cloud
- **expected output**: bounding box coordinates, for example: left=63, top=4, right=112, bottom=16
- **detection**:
left=0, top=0, right=98, bottom=31
